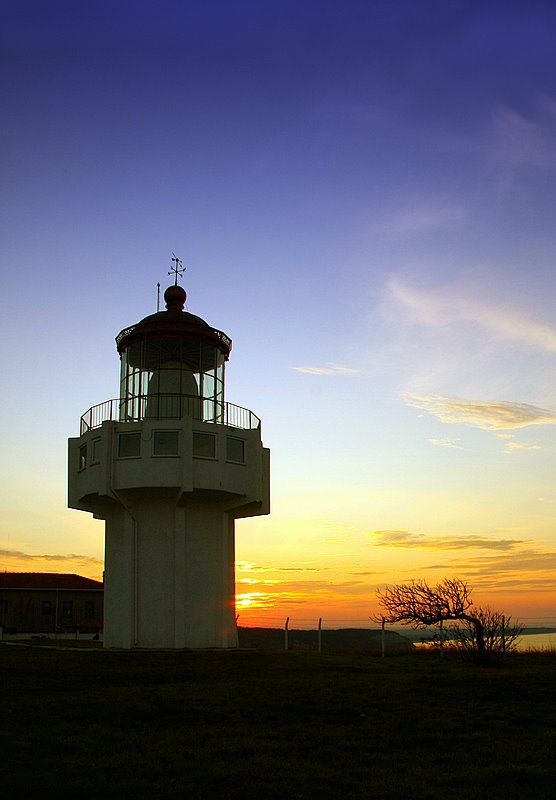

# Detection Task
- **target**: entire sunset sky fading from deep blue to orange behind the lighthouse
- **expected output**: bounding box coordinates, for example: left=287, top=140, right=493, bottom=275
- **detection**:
left=0, top=0, right=556, bottom=627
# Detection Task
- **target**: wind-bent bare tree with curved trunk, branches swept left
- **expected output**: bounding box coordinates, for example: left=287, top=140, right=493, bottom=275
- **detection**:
left=377, top=578, right=498, bottom=663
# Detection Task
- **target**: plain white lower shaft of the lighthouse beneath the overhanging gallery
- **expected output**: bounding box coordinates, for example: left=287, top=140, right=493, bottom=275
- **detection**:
left=104, top=498, right=238, bottom=649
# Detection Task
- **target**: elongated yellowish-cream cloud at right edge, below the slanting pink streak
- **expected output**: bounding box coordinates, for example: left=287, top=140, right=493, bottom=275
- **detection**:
left=402, top=392, right=556, bottom=432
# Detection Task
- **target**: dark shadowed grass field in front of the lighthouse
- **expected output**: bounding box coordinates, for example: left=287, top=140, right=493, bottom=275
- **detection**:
left=0, top=644, right=556, bottom=800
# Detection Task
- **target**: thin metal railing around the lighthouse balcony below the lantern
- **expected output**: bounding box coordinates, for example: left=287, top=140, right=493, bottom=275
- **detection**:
left=80, top=394, right=261, bottom=435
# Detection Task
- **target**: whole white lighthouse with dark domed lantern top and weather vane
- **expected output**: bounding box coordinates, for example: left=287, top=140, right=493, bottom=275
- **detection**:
left=68, top=259, right=270, bottom=649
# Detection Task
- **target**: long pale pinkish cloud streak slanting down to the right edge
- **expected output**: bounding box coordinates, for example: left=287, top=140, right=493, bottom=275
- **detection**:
left=388, top=277, right=556, bottom=352
